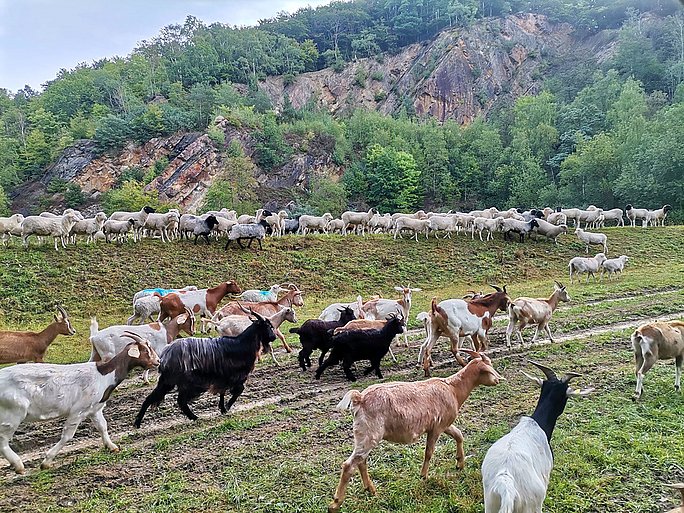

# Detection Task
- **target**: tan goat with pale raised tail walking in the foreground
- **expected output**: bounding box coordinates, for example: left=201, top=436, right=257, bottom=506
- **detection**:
left=328, top=351, right=504, bottom=513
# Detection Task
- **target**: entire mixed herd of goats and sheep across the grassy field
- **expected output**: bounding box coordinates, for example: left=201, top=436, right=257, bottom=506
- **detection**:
left=0, top=200, right=684, bottom=513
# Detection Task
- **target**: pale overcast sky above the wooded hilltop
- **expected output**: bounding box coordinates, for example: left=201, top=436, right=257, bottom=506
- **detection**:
left=0, top=0, right=330, bottom=91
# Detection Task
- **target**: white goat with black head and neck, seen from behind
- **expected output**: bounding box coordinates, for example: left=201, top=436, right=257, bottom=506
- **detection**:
left=482, top=361, right=594, bottom=513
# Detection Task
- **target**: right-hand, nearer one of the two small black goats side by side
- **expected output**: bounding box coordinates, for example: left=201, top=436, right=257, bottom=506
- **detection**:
left=316, top=317, right=404, bottom=381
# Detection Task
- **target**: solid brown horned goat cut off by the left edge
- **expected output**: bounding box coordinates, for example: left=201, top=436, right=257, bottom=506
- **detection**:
left=0, top=305, right=76, bottom=364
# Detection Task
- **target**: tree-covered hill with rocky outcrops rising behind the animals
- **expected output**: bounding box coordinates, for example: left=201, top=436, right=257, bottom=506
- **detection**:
left=0, top=0, right=684, bottom=218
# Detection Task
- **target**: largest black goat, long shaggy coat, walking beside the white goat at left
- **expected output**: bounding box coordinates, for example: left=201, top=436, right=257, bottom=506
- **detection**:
left=135, top=312, right=275, bottom=427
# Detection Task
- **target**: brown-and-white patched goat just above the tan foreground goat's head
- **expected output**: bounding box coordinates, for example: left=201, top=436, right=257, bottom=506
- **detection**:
left=418, top=285, right=511, bottom=377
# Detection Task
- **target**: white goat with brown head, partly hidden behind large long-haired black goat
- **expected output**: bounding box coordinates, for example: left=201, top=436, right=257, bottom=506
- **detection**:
left=90, top=310, right=195, bottom=383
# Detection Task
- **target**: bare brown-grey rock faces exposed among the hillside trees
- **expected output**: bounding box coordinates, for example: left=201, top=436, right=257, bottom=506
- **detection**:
left=14, top=14, right=615, bottom=212
